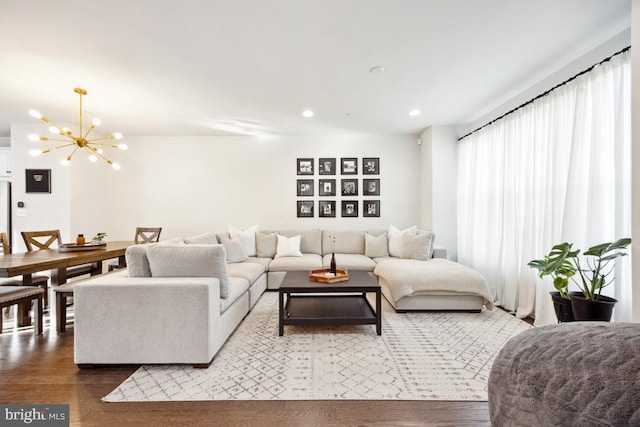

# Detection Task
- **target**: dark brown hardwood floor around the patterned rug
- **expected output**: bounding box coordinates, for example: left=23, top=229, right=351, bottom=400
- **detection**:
left=0, top=308, right=490, bottom=427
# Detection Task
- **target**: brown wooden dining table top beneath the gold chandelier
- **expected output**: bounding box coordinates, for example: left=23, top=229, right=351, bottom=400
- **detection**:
left=0, top=241, right=135, bottom=326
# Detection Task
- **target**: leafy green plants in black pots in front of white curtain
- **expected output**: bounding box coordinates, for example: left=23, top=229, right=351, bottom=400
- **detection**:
left=527, top=238, right=631, bottom=322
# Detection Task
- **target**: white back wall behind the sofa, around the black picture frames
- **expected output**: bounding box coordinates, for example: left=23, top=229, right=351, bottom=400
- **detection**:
left=12, top=131, right=420, bottom=244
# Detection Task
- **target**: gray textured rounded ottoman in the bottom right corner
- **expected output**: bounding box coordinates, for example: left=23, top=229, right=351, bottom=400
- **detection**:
left=488, top=322, right=640, bottom=427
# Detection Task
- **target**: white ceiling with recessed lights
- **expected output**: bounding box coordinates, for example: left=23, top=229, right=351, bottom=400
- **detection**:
left=0, top=0, right=631, bottom=136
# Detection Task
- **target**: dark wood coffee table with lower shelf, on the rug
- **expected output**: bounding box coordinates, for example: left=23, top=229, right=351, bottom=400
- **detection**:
left=278, top=270, right=382, bottom=336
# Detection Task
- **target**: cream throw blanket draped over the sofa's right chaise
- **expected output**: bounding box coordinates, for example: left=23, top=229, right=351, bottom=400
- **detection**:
left=373, top=258, right=493, bottom=310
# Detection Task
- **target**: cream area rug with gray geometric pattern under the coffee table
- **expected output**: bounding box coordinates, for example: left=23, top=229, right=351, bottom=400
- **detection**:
left=103, top=292, right=531, bottom=402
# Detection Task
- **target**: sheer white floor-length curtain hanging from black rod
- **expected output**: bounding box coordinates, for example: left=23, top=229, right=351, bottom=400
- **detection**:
left=458, top=50, right=631, bottom=325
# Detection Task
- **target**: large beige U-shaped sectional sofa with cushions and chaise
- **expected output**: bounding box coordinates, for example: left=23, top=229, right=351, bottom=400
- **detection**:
left=74, top=226, right=493, bottom=367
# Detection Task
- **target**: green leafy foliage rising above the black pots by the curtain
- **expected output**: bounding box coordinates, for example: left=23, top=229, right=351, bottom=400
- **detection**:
left=527, top=238, right=631, bottom=300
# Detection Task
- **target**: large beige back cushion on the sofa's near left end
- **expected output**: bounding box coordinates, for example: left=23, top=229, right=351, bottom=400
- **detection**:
left=147, top=244, right=229, bottom=298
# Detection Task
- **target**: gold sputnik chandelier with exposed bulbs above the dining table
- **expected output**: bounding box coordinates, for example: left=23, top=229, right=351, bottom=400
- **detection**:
left=29, top=87, right=127, bottom=169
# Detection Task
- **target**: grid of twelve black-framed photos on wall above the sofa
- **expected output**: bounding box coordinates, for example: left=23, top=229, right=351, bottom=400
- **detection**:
left=296, top=157, right=380, bottom=218
